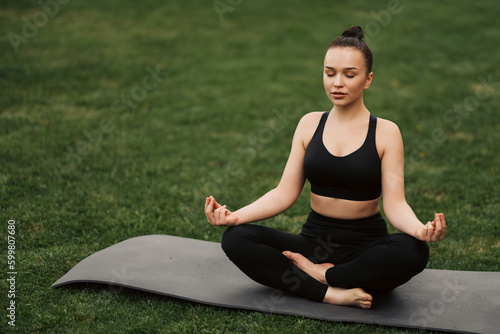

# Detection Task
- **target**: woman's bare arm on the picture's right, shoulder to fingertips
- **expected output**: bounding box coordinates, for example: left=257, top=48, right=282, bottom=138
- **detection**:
left=377, top=120, right=446, bottom=241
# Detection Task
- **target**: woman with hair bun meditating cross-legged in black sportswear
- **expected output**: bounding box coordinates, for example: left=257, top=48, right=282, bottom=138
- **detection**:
left=205, top=26, right=446, bottom=309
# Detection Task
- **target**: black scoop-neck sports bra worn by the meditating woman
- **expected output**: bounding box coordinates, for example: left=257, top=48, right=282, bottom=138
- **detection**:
left=303, top=112, right=382, bottom=201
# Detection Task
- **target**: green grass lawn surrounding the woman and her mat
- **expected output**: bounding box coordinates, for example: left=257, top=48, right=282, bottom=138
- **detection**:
left=0, top=0, right=500, bottom=333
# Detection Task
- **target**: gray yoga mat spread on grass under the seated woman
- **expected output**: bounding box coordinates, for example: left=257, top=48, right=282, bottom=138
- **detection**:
left=52, top=235, right=500, bottom=333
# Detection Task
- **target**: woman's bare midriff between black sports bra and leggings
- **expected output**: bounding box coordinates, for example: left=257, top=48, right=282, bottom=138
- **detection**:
left=311, top=193, right=380, bottom=219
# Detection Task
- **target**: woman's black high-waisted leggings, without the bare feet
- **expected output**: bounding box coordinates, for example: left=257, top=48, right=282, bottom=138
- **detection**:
left=222, top=212, right=429, bottom=302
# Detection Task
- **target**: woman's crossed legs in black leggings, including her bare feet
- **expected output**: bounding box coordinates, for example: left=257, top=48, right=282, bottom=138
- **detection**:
left=222, top=224, right=429, bottom=309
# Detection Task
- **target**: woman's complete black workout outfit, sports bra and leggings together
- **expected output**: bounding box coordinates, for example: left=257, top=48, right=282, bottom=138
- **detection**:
left=222, top=112, right=429, bottom=302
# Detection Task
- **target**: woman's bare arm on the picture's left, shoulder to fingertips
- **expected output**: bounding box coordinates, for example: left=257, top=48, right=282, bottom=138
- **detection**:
left=205, top=113, right=318, bottom=226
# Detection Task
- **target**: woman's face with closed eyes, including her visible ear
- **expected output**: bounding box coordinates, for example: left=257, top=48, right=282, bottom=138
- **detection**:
left=323, top=47, right=373, bottom=106
